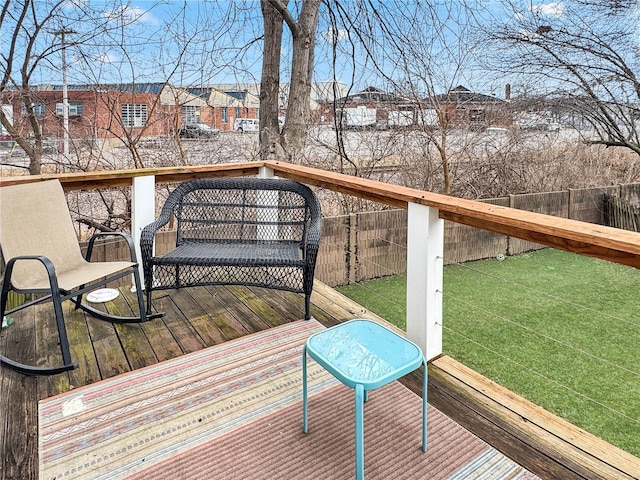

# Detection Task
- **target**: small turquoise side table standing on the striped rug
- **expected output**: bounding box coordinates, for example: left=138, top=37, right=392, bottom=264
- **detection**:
left=302, top=319, right=427, bottom=480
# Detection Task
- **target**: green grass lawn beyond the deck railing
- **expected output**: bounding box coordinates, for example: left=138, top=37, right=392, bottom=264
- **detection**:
left=338, top=249, right=640, bottom=457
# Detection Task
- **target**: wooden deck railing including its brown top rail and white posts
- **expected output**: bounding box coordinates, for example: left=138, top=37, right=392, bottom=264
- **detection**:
left=0, top=162, right=640, bottom=359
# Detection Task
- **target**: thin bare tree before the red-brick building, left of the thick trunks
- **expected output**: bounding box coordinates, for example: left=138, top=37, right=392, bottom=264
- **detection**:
left=69, top=4, right=219, bottom=168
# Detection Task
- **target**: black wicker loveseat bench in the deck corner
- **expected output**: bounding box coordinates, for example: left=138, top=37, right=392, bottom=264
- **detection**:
left=140, top=178, right=322, bottom=319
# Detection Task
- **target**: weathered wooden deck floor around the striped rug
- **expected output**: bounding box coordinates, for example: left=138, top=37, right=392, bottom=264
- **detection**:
left=0, top=283, right=640, bottom=480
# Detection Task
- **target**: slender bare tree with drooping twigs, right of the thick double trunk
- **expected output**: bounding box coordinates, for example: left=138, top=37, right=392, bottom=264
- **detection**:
left=312, top=0, right=481, bottom=194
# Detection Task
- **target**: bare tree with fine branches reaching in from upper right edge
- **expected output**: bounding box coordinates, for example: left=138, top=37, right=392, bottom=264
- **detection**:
left=486, top=0, right=640, bottom=154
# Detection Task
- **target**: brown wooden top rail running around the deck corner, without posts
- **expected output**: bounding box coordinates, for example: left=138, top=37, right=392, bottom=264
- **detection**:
left=0, top=161, right=640, bottom=268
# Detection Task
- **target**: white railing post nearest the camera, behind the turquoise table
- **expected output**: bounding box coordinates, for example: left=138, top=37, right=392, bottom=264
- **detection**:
left=407, top=203, right=444, bottom=360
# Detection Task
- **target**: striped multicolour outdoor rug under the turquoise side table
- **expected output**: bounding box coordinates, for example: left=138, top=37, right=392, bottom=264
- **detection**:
left=39, top=320, right=536, bottom=480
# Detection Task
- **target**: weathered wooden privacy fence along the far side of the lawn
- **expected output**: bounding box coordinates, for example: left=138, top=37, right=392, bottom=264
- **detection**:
left=316, top=183, right=640, bottom=286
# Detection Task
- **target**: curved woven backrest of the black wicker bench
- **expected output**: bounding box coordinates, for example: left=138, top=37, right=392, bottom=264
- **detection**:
left=161, top=178, right=321, bottom=246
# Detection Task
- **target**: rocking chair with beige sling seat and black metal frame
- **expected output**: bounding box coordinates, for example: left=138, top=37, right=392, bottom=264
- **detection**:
left=0, top=180, right=155, bottom=375
